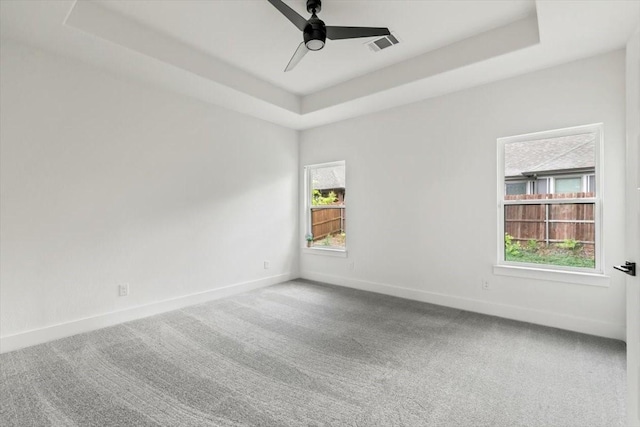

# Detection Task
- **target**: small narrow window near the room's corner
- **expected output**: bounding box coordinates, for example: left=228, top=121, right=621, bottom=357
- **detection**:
left=305, top=161, right=347, bottom=251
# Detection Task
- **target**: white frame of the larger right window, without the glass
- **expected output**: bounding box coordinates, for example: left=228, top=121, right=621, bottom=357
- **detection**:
left=494, top=123, right=608, bottom=278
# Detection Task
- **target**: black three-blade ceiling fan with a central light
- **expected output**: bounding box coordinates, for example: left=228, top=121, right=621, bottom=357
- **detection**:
left=268, top=0, right=391, bottom=72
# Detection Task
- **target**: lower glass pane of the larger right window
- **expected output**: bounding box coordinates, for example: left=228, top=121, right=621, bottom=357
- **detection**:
left=504, top=203, right=596, bottom=268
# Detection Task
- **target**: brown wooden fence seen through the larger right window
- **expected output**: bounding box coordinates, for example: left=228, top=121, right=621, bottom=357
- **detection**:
left=504, top=193, right=595, bottom=249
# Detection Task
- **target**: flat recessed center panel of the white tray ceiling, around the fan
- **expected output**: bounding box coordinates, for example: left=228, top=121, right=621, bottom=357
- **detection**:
left=91, top=0, right=535, bottom=95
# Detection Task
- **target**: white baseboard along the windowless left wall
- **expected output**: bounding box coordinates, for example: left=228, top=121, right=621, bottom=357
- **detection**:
left=0, top=273, right=298, bottom=354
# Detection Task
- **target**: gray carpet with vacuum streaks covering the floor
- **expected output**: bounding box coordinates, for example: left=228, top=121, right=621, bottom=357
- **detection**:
left=0, top=281, right=625, bottom=427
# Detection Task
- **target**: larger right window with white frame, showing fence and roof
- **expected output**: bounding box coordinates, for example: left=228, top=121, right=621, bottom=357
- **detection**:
left=498, top=124, right=603, bottom=273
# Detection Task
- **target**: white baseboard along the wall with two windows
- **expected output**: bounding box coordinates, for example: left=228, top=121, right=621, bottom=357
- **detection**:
left=301, top=271, right=626, bottom=341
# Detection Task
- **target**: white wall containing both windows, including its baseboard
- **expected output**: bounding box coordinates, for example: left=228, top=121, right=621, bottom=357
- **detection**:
left=300, top=51, right=625, bottom=339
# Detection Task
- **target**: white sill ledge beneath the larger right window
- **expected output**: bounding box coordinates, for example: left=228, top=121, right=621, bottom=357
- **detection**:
left=493, top=265, right=611, bottom=287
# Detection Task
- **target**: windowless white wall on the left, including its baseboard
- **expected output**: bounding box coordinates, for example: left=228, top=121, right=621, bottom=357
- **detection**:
left=0, top=40, right=298, bottom=351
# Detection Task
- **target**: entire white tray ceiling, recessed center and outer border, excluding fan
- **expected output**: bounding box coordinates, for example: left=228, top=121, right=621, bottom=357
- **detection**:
left=0, top=0, right=640, bottom=129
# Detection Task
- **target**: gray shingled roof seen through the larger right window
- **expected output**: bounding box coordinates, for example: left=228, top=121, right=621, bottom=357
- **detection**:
left=504, top=133, right=596, bottom=177
